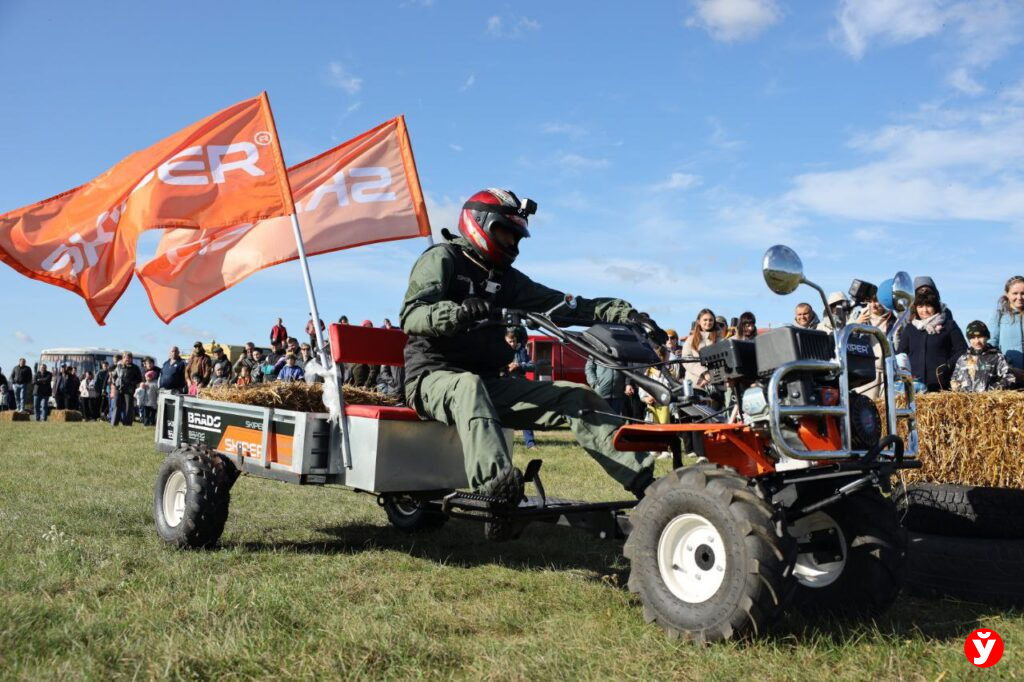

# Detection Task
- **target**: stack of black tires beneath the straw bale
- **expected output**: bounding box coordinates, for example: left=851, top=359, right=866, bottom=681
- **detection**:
left=895, top=483, right=1024, bottom=606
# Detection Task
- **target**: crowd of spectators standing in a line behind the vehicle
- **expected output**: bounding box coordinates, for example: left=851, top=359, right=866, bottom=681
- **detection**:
left=0, top=275, right=1024, bottom=430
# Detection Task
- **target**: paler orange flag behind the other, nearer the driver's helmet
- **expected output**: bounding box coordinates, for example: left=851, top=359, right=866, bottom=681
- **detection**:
left=137, top=116, right=430, bottom=323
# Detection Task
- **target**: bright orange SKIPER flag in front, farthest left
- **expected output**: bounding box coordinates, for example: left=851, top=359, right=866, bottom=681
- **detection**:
left=0, top=92, right=294, bottom=325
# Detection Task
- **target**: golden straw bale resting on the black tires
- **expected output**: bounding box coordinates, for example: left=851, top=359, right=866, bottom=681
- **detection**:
left=888, top=391, right=1024, bottom=488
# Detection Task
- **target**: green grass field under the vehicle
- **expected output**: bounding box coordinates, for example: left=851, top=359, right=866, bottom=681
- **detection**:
left=0, top=423, right=1024, bottom=680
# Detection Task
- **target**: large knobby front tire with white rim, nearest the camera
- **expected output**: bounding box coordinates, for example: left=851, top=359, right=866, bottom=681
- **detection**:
left=624, top=464, right=796, bottom=642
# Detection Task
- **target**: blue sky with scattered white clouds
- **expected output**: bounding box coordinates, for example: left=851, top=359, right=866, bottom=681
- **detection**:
left=0, top=0, right=1024, bottom=372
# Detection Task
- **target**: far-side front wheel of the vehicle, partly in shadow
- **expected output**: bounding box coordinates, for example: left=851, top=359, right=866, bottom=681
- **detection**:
left=787, top=487, right=906, bottom=617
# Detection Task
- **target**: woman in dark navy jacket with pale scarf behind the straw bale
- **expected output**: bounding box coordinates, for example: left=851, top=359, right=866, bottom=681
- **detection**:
left=896, top=293, right=967, bottom=391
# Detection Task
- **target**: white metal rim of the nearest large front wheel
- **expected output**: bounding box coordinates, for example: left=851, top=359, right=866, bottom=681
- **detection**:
left=657, top=514, right=727, bottom=604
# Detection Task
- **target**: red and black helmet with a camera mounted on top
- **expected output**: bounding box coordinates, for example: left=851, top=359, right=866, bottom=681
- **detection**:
left=459, top=188, right=537, bottom=268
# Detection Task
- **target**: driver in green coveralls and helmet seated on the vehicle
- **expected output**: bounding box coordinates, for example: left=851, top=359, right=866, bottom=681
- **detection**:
left=400, top=189, right=656, bottom=520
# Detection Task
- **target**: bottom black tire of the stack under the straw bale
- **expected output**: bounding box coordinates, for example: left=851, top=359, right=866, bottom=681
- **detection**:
left=906, top=532, right=1024, bottom=606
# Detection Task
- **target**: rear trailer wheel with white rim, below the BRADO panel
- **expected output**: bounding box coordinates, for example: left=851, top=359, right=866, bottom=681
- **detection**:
left=153, top=445, right=238, bottom=549
